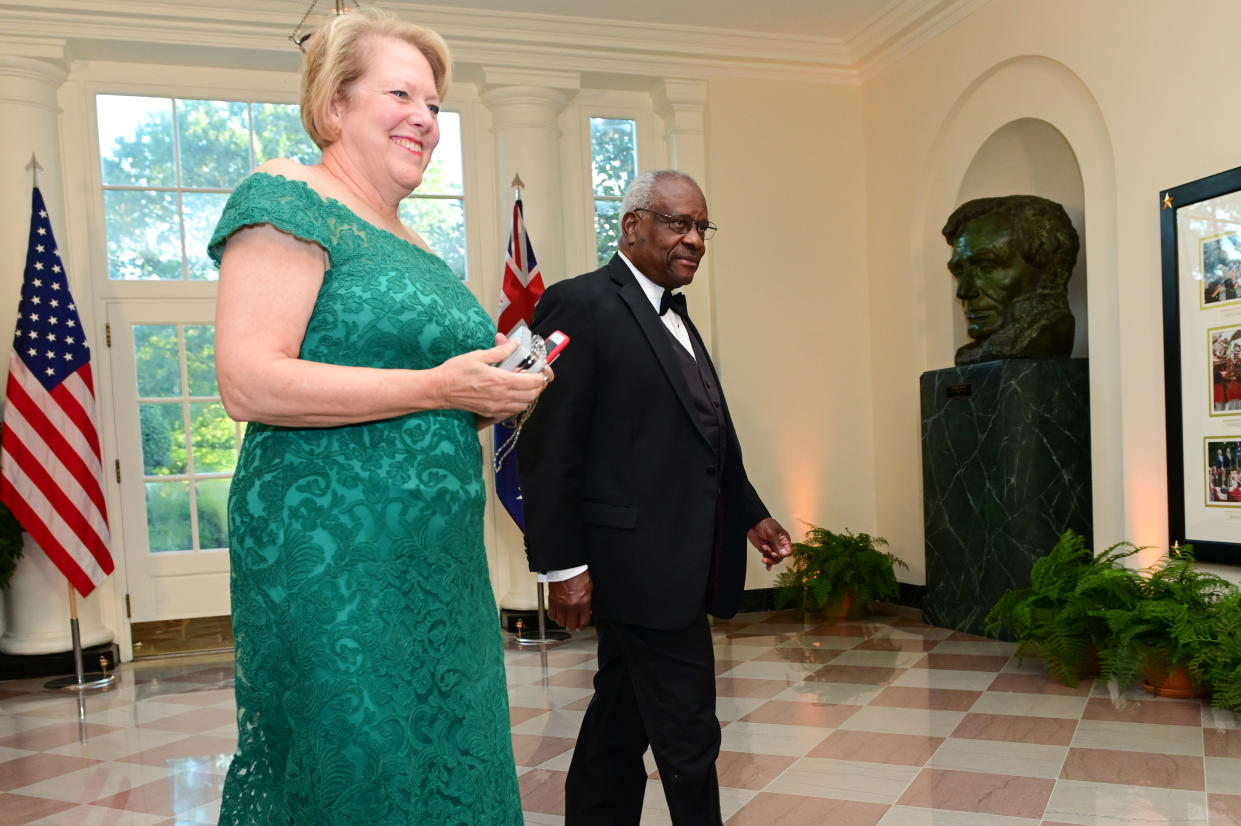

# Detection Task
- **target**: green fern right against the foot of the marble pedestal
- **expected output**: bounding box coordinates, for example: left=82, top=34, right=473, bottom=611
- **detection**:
left=984, top=531, right=1142, bottom=686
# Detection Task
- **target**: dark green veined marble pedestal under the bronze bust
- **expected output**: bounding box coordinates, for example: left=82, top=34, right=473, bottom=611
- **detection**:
left=921, top=358, right=1092, bottom=634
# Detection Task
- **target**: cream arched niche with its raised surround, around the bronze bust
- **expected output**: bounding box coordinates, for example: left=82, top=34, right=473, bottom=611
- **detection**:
left=911, top=55, right=1126, bottom=544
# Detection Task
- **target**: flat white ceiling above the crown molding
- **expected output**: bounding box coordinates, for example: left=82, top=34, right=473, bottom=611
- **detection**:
left=392, top=0, right=910, bottom=42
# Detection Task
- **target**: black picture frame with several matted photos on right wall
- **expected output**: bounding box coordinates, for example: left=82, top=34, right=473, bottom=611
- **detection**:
left=1159, top=167, right=1241, bottom=566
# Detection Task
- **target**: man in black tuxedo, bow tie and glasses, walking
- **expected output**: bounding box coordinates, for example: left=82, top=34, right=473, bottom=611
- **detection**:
left=517, top=171, right=792, bottom=826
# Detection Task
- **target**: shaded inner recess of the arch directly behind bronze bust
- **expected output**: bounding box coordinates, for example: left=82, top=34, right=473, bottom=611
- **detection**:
left=943, top=118, right=1090, bottom=358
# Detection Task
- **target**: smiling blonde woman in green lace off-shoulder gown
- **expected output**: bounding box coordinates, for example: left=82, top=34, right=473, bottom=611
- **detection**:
left=210, top=9, right=550, bottom=826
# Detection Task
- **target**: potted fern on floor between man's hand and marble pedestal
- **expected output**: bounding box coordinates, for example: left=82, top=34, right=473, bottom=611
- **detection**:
left=776, top=525, right=908, bottom=619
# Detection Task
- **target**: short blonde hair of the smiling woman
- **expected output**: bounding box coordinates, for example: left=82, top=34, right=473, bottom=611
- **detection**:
left=302, top=6, right=452, bottom=149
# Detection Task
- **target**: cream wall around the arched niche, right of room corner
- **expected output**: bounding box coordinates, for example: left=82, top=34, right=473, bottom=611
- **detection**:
left=862, top=0, right=1241, bottom=582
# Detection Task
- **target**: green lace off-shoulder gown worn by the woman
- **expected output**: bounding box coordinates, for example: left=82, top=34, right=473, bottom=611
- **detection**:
left=210, top=174, right=521, bottom=826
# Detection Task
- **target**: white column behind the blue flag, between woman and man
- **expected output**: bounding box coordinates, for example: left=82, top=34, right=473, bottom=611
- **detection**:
left=482, top=67, right=581, bottom=610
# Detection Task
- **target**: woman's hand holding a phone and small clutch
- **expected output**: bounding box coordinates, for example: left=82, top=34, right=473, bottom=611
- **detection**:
left=436, top=332, right=551, bottom=423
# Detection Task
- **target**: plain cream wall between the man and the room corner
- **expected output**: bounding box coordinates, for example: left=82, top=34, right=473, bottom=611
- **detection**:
left=707, top=79, right=873, bottom=588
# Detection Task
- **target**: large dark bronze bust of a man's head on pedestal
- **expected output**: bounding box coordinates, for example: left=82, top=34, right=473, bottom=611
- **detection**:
left=943, top=195, right=1078, bottom=365
